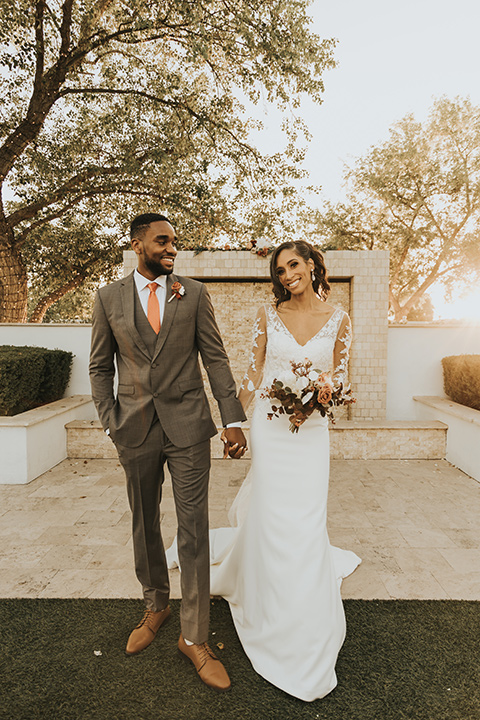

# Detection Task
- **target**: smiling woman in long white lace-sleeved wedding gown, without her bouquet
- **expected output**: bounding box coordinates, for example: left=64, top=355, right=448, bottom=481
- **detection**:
left=170, top=241, right=360, bottom=701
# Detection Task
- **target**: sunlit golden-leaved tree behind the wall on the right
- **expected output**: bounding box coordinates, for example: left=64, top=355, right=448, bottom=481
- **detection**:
left=313, top=98, right=480, bottom=321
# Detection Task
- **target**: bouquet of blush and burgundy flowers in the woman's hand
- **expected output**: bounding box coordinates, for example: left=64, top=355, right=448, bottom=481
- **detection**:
left=260, top=360, right=355, bottom=433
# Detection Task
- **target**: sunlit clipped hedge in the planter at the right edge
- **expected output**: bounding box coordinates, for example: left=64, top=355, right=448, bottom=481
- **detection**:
left=442, top=355, right=480, bottom=410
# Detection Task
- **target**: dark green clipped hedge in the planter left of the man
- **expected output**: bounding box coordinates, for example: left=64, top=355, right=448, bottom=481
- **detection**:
left=0, top=345, right=73, bottom=415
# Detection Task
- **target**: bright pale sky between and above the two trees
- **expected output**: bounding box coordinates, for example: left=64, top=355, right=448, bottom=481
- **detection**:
left=249, top=0, right=480, bottom=320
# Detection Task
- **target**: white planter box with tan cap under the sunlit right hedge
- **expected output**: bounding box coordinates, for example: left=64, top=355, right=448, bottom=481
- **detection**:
left=413, top=395, right=480, bottom=481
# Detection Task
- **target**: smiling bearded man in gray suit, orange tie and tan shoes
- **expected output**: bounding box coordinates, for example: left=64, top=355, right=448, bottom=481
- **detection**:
left=90, top=213, right=246, bottom=690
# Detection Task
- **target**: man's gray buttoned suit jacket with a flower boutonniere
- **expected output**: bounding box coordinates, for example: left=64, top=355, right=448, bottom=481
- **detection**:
left=90, top=273, right=245, bottom=447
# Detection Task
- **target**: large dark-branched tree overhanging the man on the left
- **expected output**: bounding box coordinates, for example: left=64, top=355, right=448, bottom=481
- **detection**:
left=0, top=0, right=333, bottom=322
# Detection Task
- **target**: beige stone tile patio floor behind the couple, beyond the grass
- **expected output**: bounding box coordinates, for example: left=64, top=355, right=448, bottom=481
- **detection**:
left=0, top=460, right=480, bottom=600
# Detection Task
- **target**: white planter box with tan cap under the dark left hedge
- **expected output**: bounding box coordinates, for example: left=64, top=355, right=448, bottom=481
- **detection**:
left=0, top=395, right=95, bottom=485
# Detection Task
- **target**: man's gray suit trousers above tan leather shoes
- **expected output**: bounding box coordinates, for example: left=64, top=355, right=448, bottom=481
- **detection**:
left=116, top=419, right=210, bottom=643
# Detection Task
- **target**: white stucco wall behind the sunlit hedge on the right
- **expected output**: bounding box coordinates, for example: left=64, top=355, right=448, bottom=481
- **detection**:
left=387, top=323, right=480, bottom=420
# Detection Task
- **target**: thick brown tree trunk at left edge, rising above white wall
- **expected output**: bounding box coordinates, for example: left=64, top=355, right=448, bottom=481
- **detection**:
left=0, top=233, right=27, bottom=323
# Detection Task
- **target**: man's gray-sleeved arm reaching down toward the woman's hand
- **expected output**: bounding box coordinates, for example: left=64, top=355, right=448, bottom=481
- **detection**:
left=196, top=285, right=246, bottom=429
